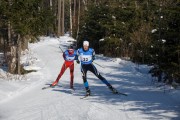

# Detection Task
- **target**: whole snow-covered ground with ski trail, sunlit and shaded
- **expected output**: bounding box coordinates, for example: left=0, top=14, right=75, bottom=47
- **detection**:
left=0, top=36, right=180, bottom=120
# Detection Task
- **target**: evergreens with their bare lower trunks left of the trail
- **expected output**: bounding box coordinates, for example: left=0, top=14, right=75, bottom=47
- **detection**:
left=0, top=0, right=55, bottom=74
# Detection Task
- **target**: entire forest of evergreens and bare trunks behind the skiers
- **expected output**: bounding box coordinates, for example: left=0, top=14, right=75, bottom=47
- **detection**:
left=0, top=0, right=180, bottom=83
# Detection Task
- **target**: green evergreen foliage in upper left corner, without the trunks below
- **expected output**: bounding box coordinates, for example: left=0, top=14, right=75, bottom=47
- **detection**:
left=0, top=0, right=55, bottom=40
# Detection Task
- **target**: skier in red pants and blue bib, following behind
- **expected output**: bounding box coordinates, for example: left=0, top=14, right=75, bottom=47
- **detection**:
left=50, top=46, right=76, bottom=89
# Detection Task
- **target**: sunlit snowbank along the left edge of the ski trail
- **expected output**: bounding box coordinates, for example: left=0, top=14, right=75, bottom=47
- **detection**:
left=0, top=37, right=46, bottom=102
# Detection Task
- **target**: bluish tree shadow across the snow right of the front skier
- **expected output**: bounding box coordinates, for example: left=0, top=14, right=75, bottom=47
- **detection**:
left=76, top=63, right=180, bottom=120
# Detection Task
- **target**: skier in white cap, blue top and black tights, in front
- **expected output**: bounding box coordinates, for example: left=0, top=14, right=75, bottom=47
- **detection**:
left=77, top=41, right=118, bottom=95
